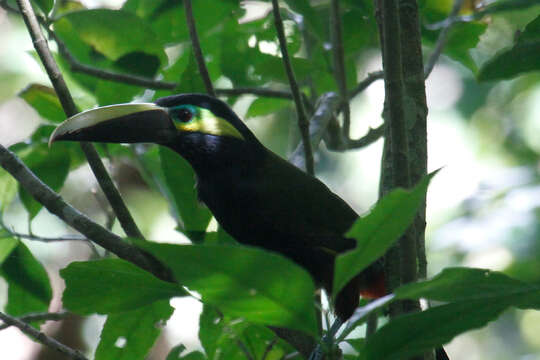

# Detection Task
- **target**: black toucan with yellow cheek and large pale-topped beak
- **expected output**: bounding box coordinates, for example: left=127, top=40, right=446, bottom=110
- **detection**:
left=49, top=93, right=386, bottom=322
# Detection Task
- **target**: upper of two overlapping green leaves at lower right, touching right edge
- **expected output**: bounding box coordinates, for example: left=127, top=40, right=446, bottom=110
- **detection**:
left=395, top=268, right=540, bottom=309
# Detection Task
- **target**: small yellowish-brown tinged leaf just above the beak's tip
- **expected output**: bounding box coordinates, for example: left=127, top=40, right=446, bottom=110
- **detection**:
left=19, top=84, right=66, bottom=123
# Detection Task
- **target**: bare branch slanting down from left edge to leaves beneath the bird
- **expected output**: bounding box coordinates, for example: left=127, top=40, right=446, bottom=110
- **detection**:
left=0, top=145, right=173, bottom=281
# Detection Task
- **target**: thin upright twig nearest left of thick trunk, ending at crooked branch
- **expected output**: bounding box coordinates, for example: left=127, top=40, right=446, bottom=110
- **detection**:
left=330, top=0, right=351, bottom=138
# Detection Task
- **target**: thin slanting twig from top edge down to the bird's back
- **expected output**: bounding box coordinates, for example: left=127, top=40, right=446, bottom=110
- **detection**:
left=272, top=0, right=314, bottom=175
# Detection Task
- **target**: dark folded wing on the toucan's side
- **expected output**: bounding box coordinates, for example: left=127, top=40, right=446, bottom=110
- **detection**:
left=248, top=153, right=358, bottom=252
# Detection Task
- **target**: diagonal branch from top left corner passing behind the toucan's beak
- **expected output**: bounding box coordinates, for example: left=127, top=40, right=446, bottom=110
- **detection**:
left=17, top=0, right=143, bottom=242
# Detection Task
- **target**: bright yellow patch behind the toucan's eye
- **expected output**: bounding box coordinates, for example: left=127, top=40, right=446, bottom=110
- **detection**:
left=175, top=108, right=244, bottom=140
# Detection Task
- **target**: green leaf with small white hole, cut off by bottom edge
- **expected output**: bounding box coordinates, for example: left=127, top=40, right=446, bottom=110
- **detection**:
left=95, top=300, right=174, bottom=360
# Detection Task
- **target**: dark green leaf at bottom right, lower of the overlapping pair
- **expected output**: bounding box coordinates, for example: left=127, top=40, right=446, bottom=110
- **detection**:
left=360, top=300, right=506, bottom=360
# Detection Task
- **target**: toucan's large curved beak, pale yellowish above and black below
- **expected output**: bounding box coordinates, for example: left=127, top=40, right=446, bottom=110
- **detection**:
left=49, top=103, right=177, bottom=146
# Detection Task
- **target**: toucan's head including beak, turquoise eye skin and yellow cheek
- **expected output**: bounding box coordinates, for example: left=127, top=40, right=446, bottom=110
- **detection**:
left=49, top=94, right=262, bottom=171
